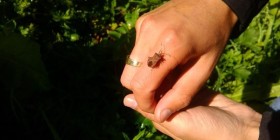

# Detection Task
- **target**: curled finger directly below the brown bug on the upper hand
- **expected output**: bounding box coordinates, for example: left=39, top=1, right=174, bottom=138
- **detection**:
left=131, top=53, right=176, bottom=113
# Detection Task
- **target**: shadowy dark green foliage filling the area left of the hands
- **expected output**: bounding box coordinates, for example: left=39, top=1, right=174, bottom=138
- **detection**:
left=0, top=0, right=167, bottom=140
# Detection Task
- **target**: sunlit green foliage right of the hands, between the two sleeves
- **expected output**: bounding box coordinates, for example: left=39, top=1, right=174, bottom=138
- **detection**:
left=209, top=0, right=280, bottom=111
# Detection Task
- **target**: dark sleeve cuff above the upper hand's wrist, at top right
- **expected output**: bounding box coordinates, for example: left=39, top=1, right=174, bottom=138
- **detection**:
left=223, top=0, right=268, bottom=38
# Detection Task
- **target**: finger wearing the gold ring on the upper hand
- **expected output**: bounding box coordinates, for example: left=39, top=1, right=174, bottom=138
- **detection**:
left=121, top=7, right=170, bottom=89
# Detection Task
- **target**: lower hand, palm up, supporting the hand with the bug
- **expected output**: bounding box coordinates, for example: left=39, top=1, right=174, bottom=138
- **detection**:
left=124, top=90, right=261, bottom=140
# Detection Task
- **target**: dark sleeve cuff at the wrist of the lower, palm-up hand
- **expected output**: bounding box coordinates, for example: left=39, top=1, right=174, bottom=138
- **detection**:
left=259, top=112, right=280, bottom=140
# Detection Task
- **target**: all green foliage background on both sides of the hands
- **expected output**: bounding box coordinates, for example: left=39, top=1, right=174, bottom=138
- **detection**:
left=0, top=0, right=280, bottom=140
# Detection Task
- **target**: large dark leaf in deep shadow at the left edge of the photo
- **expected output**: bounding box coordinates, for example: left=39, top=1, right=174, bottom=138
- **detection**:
left=0, top=32, right=50, bottom=90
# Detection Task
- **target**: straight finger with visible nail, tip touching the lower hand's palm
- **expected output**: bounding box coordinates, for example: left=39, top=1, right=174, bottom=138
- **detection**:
left=155, top=56, right=219, bottom=122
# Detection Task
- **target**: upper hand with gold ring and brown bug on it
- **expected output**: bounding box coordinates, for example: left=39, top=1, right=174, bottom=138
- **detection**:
left=121, top=0, right=237, bottom=122
